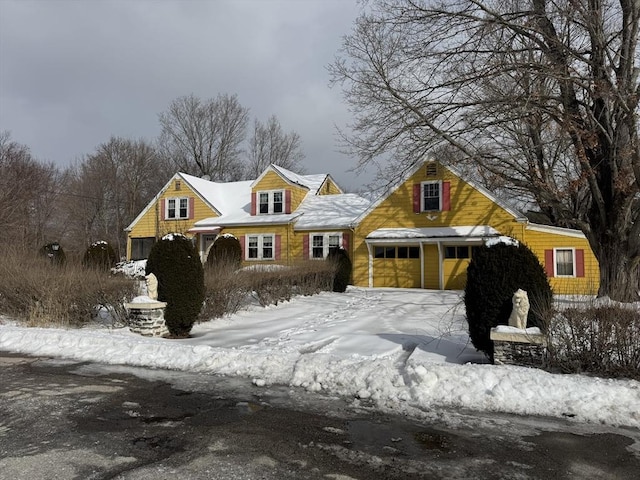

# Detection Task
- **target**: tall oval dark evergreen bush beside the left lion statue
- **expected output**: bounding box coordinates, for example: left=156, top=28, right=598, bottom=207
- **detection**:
left=145, top=234, right=205, bottom=338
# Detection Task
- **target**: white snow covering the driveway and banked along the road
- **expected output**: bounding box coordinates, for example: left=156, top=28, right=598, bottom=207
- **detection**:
left=0, top=287, right=640, bottom=427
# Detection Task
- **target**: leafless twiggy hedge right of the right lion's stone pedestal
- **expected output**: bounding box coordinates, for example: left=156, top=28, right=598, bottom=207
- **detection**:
left=549, top=304, right=640, bottom=380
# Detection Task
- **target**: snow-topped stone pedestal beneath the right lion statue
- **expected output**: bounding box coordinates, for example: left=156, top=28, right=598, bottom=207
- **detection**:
left=490, top=325, right=547, bottom=367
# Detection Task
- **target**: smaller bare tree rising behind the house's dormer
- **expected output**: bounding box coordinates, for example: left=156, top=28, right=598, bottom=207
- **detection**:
left=246, top=115, right=304, bottom=178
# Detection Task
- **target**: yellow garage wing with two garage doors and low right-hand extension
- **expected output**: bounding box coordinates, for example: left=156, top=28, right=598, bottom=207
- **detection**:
left=352, top=161, right=599, bottom=294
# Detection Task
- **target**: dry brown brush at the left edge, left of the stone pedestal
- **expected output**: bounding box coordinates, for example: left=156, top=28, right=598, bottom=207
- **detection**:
left=0, top=247, right=137, bottom=327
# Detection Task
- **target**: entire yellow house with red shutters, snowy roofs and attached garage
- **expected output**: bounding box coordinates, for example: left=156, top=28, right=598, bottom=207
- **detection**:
left=128, top=161, right=599, bottom=294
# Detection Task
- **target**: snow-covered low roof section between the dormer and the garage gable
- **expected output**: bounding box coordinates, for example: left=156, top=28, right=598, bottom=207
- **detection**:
left=294, top=193, right=371, bottom=230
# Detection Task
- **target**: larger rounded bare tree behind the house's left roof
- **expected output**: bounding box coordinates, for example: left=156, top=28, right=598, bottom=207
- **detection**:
left=159, top=95, right=249, bottom=181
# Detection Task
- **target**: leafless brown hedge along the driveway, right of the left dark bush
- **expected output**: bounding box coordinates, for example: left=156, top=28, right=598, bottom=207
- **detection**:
left=200, top=260, right=335, bottom=321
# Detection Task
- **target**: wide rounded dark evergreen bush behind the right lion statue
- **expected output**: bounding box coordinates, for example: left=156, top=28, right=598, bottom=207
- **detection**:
left=464, top=243, right=553, bottom=361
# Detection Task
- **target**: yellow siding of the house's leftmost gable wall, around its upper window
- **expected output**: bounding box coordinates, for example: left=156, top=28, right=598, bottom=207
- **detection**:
left=127, top=180, right=218, bottom=258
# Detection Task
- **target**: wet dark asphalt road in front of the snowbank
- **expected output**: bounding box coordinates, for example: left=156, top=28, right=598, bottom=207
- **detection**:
left=0, top=353, right=640, bottom=480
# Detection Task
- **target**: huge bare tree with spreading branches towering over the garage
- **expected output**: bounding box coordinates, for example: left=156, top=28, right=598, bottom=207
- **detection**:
left=330, top=0, right=640, bottom=301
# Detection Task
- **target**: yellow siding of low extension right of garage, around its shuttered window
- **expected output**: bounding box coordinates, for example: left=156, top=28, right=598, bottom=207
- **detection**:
left=524, top=229, right=600, bottom=295
